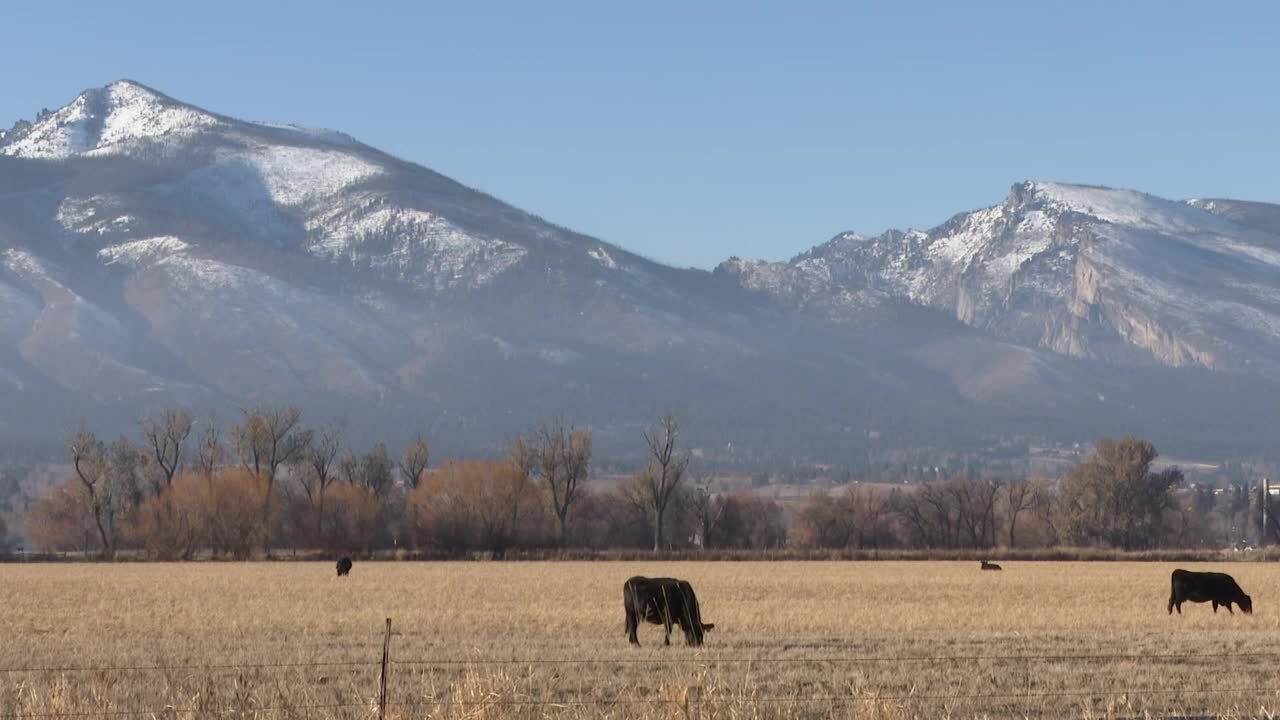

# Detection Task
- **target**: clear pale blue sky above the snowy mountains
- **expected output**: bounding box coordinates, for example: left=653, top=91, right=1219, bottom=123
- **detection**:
left=0, top=0, right=1280, bottom=268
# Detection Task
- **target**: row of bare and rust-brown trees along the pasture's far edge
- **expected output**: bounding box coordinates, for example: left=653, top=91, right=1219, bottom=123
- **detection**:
left=24, top=407, right=1274, bottom=559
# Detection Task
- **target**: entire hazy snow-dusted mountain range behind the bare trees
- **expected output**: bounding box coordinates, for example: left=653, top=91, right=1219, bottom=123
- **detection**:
left=0, top=81, right=1280, bottom=466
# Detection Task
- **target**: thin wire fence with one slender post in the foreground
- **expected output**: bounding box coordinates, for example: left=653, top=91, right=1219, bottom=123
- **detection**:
left=0, top=619, right=1280, bottom=720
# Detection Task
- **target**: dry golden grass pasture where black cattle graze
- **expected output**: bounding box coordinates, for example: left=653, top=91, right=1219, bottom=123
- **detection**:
left=0, top=561, right=1280, bottom=720
